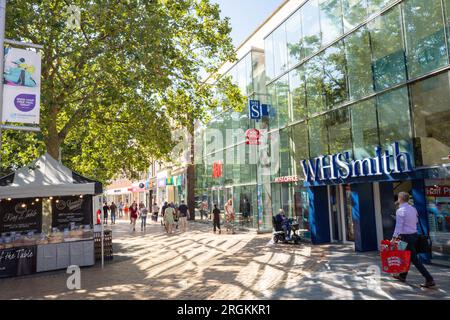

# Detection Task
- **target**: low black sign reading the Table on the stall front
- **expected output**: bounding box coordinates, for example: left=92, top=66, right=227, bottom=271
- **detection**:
left=0, top=246, right=37, bottom=278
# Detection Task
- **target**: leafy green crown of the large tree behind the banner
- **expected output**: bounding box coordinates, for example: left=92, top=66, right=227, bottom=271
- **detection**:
left=2, top=0, right=242, bottom=181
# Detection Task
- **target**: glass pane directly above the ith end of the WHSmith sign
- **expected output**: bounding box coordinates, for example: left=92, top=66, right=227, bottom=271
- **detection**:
left=377, top=87, right=411, bottom=150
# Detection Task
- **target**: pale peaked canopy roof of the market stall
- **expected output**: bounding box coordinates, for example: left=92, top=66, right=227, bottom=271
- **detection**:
left=0, top=153, right=103, bottom=198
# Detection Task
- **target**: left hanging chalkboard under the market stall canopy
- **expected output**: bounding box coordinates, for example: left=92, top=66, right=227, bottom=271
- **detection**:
left=0, top=199, right=42, bottom=233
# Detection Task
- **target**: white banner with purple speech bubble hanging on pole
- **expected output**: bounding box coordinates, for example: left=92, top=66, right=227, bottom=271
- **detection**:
left=2, top=48, right=41, bottom=124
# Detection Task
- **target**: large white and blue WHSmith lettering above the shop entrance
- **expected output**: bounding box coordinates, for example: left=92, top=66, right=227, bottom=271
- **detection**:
left=301, top=142, right=413, bottom=182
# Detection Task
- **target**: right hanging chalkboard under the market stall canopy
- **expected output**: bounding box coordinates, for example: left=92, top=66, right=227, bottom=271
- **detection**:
left=52, top=197, right=92, bottom=230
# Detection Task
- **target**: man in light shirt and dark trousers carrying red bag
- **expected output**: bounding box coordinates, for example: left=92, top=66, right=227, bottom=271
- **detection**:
left=393, top=192, right=436, bottom=288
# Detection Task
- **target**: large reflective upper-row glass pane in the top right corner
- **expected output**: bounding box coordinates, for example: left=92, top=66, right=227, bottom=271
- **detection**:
left=403, top=0, right=447, bottom=78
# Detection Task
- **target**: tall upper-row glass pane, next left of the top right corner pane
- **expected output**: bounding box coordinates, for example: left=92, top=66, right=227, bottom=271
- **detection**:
left=368, top=6, right=406, bottom=91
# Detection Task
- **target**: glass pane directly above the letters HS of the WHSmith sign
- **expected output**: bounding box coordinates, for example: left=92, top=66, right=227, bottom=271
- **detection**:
left=326, top=108, right=352, bottom=154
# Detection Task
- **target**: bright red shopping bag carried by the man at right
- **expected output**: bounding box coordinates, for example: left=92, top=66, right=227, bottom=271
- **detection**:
left=380, top=240, right=411, bottom=273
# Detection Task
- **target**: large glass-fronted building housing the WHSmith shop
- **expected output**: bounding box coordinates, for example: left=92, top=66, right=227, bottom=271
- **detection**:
left=198, top=0, right=450, bottom=261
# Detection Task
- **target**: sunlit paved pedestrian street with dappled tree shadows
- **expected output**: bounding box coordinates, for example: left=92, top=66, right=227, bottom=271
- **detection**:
left=0, top=221, right=450, bottom=300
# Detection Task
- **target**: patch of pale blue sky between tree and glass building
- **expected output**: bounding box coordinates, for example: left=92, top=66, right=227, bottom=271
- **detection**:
left=211, top=0, right=284, bottom=47
